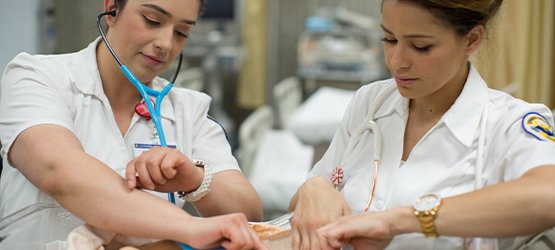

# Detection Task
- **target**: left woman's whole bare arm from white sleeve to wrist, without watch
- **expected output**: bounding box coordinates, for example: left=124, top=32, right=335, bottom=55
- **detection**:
left=9, top=125, right=195, bottom=243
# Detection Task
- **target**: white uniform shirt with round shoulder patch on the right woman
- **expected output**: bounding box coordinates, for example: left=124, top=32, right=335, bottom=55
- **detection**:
left=308, top=65, right=555, bottom=249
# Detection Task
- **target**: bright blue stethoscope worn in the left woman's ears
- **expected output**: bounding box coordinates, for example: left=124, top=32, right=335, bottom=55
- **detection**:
left=96, top=10, right=183, bottom=204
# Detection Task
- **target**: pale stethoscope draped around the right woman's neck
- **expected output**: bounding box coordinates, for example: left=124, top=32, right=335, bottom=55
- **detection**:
left=332, top=84, right=489, bottom=212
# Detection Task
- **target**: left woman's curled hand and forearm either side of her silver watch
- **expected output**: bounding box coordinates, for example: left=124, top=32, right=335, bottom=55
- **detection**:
left=126, top=147, right=262, bottom=221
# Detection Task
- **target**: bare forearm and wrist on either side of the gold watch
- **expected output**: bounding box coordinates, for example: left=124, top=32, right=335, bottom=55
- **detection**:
left=395, top=166, right=555, bottom=237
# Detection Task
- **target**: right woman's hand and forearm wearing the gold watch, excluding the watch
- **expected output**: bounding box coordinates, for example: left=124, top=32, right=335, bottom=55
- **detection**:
left=318, top=165, right=555, bottom=249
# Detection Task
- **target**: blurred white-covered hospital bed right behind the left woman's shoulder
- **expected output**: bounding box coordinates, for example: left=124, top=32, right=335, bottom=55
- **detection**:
left=238, top=105, right=314, bottom=219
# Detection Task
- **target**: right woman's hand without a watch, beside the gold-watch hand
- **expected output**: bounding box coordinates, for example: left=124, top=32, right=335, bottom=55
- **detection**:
left=290, top=177, right=351, bottom=250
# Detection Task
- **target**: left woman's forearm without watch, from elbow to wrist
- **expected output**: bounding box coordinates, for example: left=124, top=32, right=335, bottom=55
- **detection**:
left=52, top=159, right=195, bottom=242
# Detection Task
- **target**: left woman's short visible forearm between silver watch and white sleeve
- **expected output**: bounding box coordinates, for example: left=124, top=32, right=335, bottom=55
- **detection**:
left=193, top=171, right=262, bottom=221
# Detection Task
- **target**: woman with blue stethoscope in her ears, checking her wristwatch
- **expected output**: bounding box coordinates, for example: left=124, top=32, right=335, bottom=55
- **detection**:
left=0, top=0, right=265, bottom=249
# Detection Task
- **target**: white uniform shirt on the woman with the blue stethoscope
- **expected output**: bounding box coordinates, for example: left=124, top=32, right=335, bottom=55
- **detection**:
left=0, top=39, right=239, bottom=231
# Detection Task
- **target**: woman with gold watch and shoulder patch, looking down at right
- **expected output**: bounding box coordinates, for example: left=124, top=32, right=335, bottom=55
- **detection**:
left=290, top=0, right=555, bottom=249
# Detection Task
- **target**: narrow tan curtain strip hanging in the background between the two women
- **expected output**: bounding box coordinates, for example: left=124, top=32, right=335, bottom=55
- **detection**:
left=237, top=0, right=268, bottom=109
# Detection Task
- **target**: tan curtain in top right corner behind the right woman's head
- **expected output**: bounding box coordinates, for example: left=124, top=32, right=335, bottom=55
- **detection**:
left=471, top=0, right=555, bottom=108
